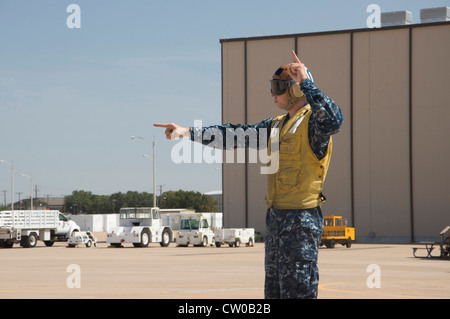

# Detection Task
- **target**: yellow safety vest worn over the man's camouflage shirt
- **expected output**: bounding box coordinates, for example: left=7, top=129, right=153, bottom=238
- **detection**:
left=266, top=104, right=332, bottom=209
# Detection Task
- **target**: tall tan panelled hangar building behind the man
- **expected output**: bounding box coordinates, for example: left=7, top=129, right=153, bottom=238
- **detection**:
left=220, top=11, right=450, bottom=243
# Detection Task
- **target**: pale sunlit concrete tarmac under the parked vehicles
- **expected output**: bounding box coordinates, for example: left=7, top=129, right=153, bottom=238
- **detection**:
left=0, top=233, right=450, bottom=300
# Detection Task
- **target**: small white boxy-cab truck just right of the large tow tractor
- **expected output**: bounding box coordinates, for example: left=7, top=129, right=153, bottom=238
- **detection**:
left=177, top=214, right=214, bottom=247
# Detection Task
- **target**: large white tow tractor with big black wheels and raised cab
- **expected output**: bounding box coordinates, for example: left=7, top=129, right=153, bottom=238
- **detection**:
left=106, top=207, right=173, bottom=247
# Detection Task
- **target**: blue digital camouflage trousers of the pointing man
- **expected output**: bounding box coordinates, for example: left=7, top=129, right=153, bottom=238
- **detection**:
left=264, top=207, right=323, bottom=299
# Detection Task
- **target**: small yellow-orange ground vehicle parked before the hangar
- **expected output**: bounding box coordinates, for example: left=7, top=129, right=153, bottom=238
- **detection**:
left=320, top=215, right=355, bottom=248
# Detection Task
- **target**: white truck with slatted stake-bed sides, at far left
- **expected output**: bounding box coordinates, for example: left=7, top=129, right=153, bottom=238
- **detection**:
left=0, top=210, right=80, bottom=248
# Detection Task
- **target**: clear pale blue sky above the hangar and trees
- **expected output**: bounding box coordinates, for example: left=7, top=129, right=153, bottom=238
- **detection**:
left=0, top=0, right=450, bottom=204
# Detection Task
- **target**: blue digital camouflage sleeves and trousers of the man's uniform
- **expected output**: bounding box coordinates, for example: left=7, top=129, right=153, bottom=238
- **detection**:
left=191, top=79, right=343, bottom=299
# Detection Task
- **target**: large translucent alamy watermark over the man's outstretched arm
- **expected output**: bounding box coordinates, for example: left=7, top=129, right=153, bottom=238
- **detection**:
left=170, top=120, right=279, bottom=174
